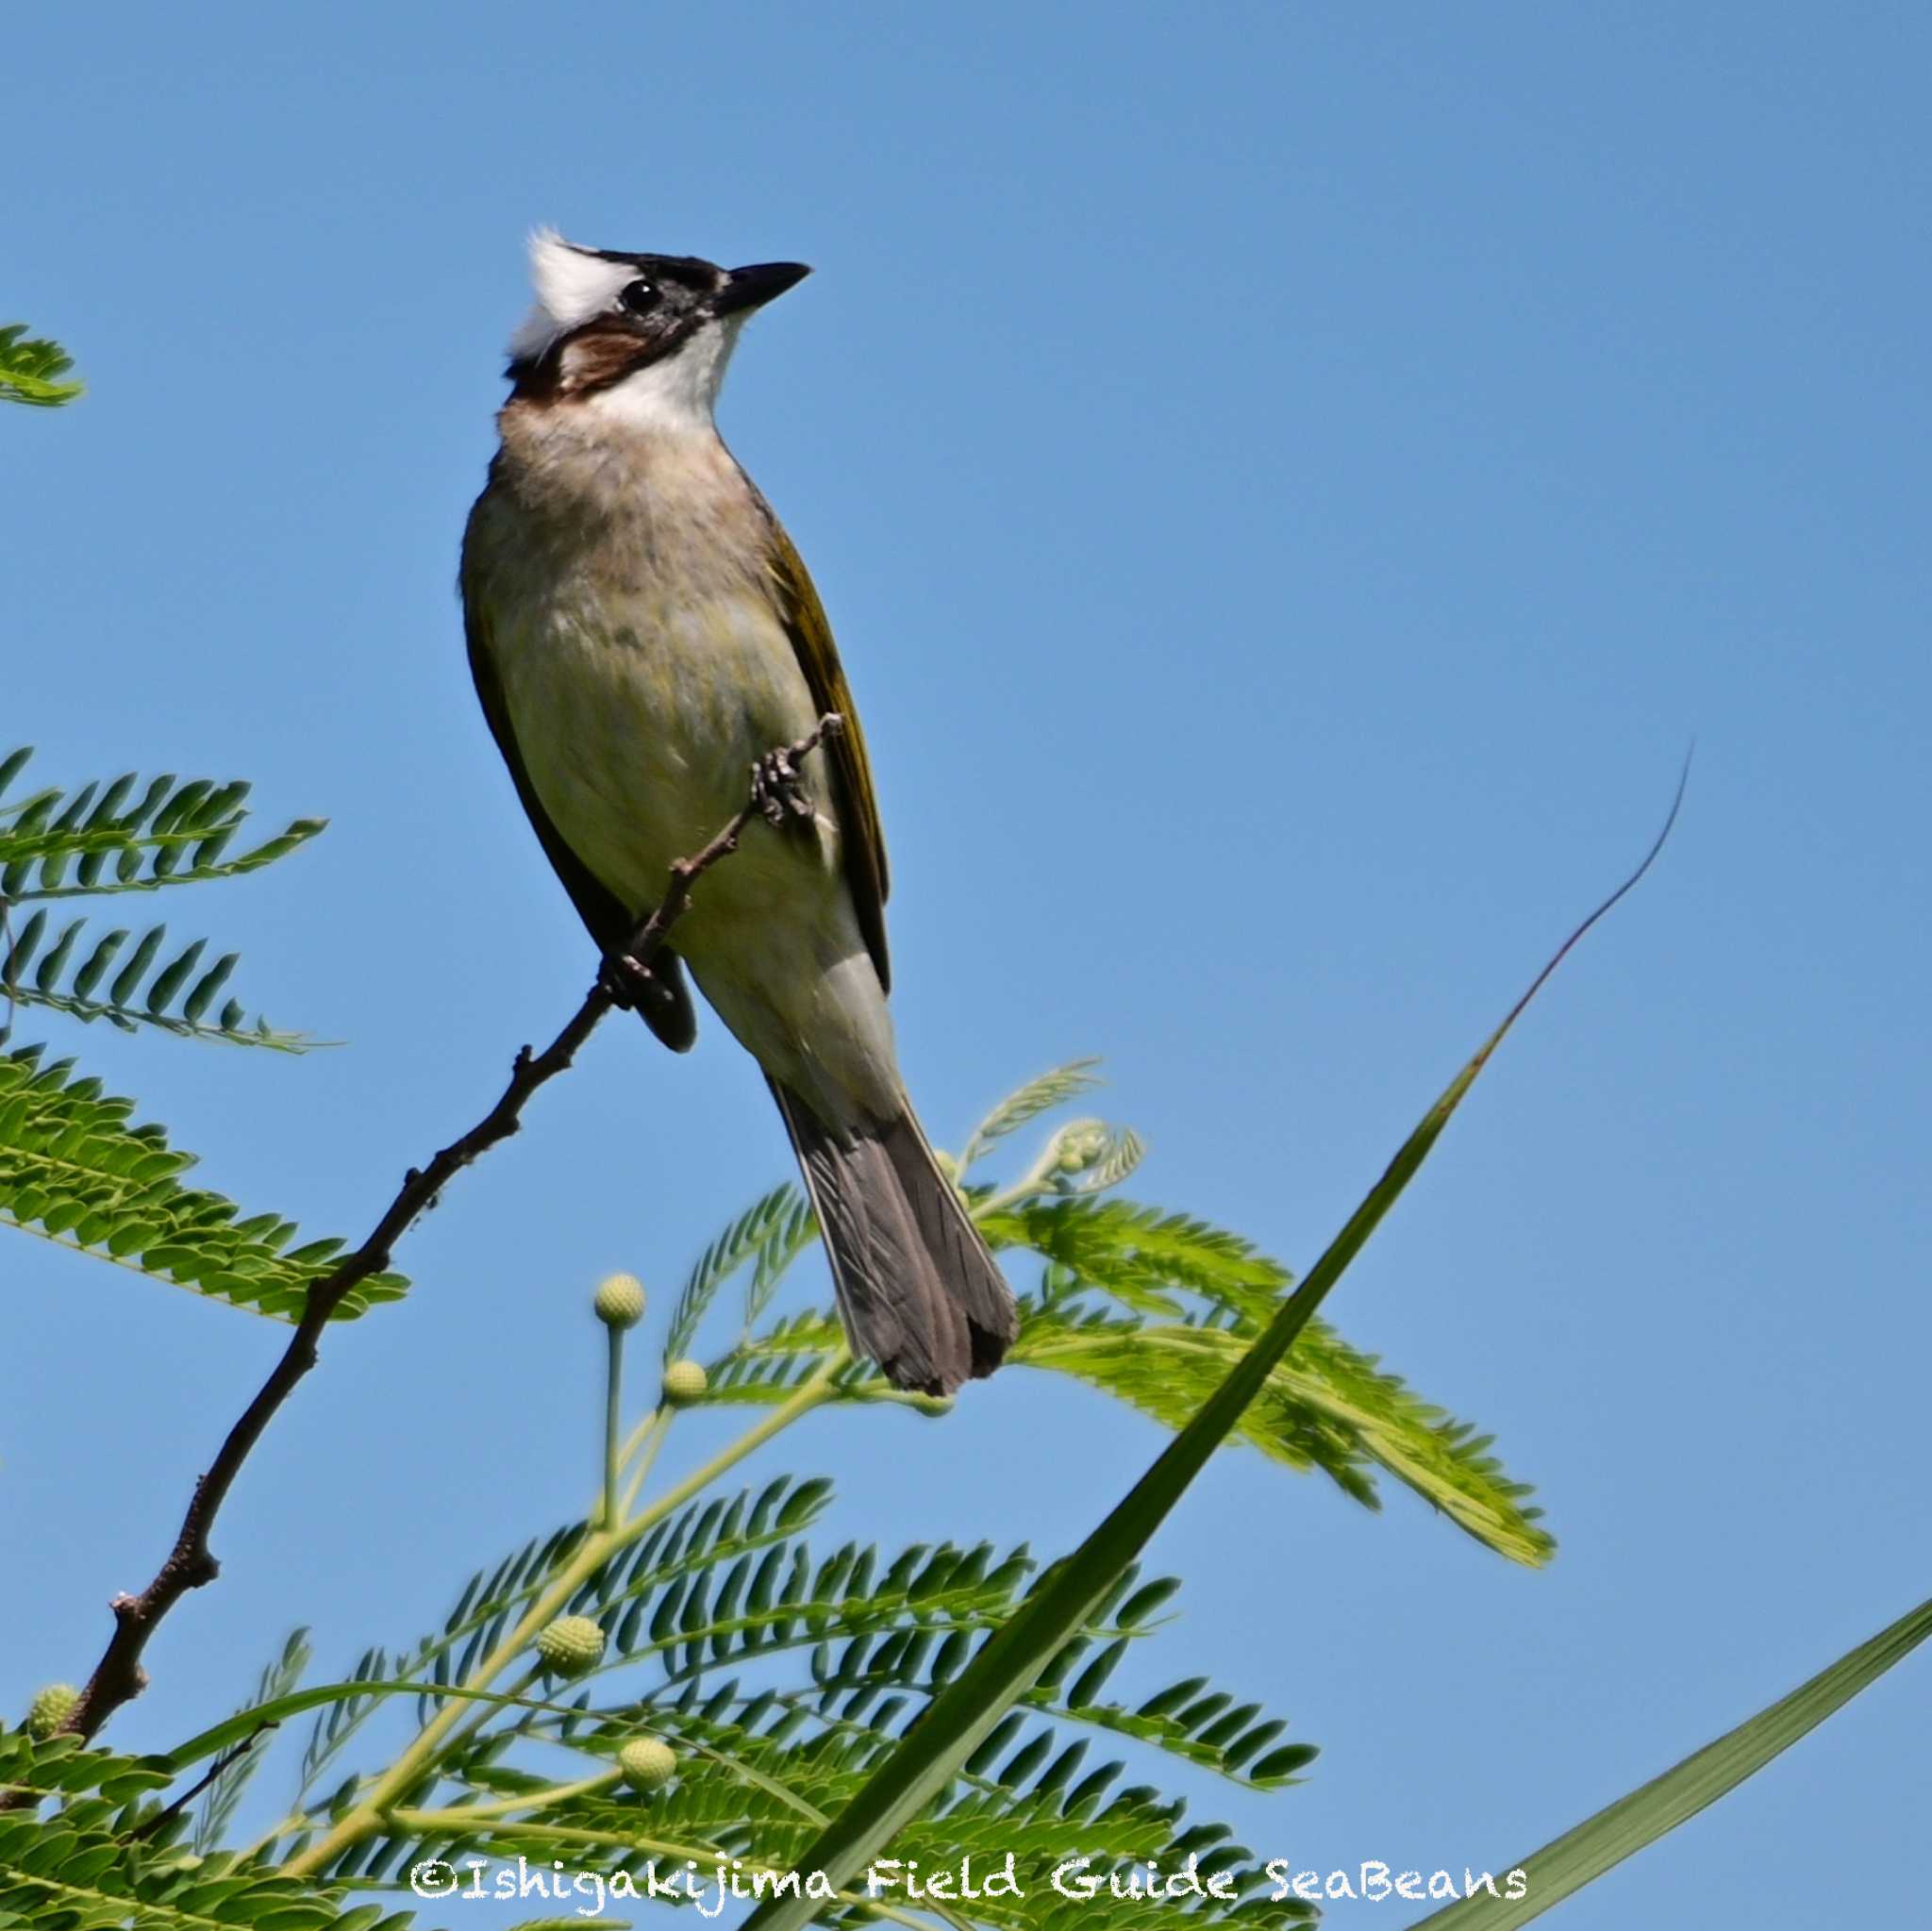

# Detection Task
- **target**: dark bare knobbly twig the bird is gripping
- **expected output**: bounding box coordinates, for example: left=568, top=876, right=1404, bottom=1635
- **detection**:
left=42, top=712, right=844, bottom=1760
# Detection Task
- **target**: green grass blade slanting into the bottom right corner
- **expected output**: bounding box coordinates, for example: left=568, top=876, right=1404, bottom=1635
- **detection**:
left=1414, top=1601, right=1932, bottom=1931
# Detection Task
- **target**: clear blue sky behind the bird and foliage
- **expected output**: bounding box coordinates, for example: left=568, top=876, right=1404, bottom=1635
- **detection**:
left=0, top=0, right=1932, bottom=1931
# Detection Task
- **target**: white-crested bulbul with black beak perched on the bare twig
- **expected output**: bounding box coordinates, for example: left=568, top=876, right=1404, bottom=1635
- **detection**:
left=461, top=232, right=1014, bottom=1394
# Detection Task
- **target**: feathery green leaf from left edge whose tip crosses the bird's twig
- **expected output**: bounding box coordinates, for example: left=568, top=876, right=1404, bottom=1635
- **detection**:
left=0, top=1046, right=408, bottom=1321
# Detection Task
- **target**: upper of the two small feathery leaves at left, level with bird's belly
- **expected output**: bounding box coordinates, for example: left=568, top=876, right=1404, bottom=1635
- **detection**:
left=0, top=747, right=326, bottom=904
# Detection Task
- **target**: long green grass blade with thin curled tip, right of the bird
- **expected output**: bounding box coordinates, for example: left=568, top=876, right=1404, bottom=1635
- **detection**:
left=746, top=780, right=1683, bottom=1931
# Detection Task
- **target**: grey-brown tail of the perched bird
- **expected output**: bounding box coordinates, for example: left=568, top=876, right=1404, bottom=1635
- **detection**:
left=771, top=1079, right=1018, bottom=1394
